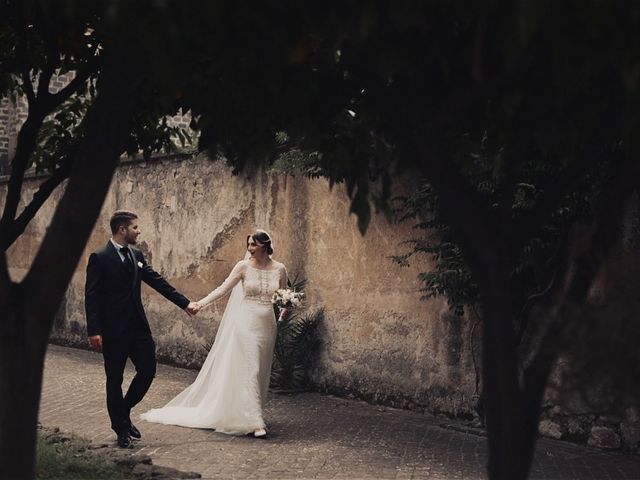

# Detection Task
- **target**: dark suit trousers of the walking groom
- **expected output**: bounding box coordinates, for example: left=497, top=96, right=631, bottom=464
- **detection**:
left=102, top=322, right=156, bottom=434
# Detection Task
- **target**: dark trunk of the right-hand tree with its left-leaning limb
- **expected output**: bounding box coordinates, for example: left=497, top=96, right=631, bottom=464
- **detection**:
left=416, top=143, right=528, bottom=480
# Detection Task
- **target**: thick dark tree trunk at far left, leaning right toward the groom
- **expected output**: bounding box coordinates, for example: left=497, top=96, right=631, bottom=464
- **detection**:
left=0, top=54, right=136, bottom=480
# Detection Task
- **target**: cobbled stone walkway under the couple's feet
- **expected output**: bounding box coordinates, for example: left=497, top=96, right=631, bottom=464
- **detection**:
left=40, top=345, right=640, bottom=480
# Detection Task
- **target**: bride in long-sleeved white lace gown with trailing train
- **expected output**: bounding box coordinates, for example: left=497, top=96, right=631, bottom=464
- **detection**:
left=140, top=230, right=287, bottom=437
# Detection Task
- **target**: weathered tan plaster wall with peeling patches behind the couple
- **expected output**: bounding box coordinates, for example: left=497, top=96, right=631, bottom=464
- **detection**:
left=0, top=157, right=475, bottom=413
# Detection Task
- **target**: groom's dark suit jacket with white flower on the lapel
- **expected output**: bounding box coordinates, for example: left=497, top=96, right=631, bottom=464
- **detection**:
left=84, top=241, right=189, bottom=337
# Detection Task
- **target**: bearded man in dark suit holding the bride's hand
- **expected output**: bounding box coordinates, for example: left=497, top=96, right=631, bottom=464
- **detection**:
left=85, top=210, right=195, bottom=448
